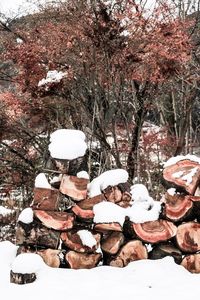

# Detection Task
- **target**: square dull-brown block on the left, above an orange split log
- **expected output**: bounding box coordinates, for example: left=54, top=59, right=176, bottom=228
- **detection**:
left=31, top=188, right=62, bottom=210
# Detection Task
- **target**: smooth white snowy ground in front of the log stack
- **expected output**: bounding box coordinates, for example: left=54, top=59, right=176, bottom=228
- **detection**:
left=0, top=241, right=200, bottom=300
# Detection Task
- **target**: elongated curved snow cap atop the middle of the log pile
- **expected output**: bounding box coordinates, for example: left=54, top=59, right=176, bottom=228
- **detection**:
left=88, top=169, right=128, bottom=197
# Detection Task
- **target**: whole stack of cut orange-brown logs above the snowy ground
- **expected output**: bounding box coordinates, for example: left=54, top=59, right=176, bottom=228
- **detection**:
left=13, top=159, right=200, bottom=282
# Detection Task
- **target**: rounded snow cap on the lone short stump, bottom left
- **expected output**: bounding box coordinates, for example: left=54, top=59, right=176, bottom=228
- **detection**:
left=11, top=253, right=46, bottom=274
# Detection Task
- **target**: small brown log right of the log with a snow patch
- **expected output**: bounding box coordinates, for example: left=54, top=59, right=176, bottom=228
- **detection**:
left=101, top=232, right=125, bottom=255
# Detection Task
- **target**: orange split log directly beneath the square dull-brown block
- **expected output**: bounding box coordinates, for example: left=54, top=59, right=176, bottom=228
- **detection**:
left=34, top=210, right=75, bottom=230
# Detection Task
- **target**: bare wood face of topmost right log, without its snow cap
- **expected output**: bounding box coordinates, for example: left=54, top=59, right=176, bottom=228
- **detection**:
left=163, top=159, right=200, bottom=195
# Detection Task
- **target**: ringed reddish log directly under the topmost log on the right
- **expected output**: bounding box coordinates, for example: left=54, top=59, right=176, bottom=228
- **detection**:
left=162, top=193, right=193, bottom=222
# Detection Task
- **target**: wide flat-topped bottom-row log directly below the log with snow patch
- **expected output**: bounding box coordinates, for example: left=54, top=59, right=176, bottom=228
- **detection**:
left=65, top=251, right=102, bottom=269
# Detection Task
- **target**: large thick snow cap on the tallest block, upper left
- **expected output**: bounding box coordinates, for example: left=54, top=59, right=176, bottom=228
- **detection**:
left=49, top=129, right=87, bottom=160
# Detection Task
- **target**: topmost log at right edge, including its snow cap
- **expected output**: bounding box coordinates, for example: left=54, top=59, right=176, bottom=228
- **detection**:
left=163, top=155, right=200, bottom=195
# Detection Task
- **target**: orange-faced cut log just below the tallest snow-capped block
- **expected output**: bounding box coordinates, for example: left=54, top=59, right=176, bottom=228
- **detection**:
left=60, top=175, right=89, bottom=201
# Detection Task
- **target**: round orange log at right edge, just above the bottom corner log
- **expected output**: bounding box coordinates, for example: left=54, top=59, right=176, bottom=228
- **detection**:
left=176, top=222, right=200, bottom=253
